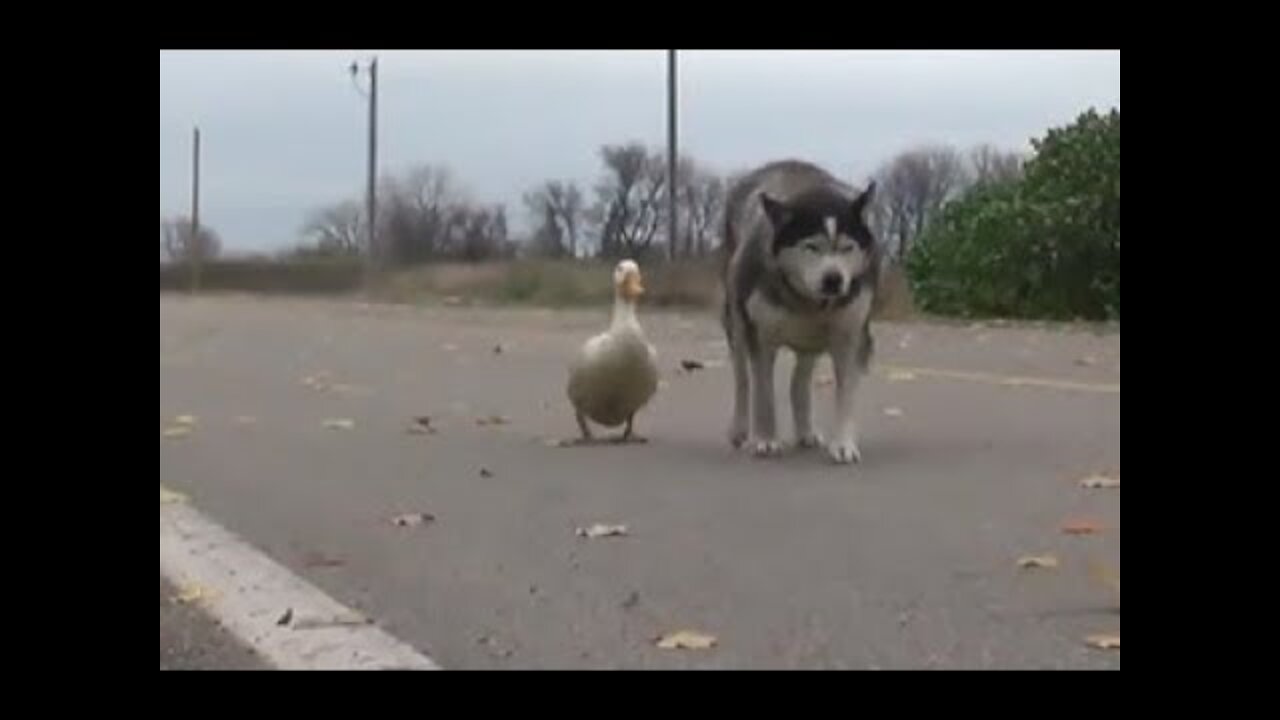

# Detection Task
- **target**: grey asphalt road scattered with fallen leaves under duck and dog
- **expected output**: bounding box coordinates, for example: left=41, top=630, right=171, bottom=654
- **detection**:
left=160, top=295, right=1120, bottom=669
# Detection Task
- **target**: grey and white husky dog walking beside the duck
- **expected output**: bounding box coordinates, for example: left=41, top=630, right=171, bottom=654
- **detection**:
left=722, top=160, right=882, bottom=464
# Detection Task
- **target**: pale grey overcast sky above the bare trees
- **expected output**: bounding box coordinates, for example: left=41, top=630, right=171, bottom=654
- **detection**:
left=160, top=50, right=1120, bottom=251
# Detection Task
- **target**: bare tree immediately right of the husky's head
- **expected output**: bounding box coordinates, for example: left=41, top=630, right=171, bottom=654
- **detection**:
left=873, top=146, right=968, bottom=258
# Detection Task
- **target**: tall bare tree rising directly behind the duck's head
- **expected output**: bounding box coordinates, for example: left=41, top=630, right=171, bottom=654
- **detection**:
left=588, top=142, right=667, bottom=258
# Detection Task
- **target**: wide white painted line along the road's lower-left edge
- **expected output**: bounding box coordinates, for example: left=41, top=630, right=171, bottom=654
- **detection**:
left=160, top=487, right=440, bottom=670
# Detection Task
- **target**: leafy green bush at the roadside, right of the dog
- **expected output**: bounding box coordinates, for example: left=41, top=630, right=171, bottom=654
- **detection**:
left=906, top=110, right=1120, bottom=319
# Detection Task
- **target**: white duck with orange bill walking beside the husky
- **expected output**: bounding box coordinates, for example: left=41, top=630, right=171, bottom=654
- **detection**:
left=568, top=254, right=658, bottom=442
